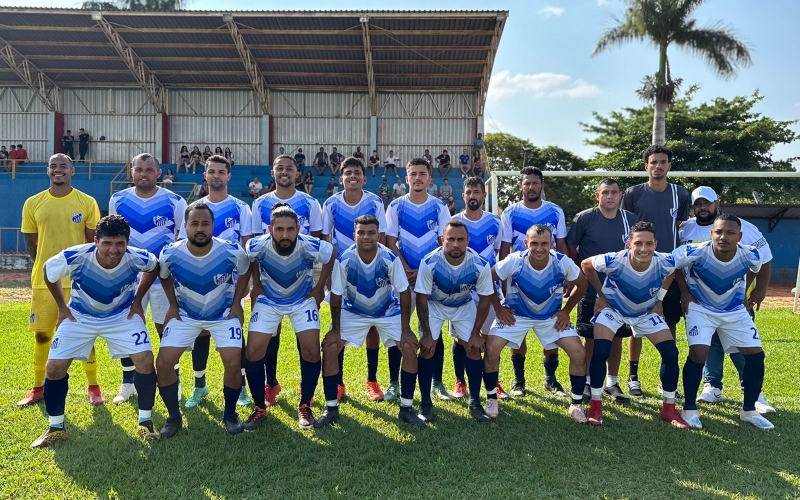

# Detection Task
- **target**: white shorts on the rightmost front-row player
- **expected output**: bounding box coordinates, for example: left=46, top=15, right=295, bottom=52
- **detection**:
left=686, top=302, right=761, bottom=353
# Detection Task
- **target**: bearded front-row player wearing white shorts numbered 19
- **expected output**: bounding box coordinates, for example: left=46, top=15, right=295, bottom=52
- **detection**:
left=151, top=203, right=250, bottom=438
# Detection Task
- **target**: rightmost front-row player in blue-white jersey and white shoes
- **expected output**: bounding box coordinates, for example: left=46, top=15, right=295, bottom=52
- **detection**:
left=673, top=213, right=774, bottom=429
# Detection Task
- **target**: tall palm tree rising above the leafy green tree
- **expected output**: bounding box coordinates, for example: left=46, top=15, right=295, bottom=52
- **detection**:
left=592, top=0, right=752, bottom=145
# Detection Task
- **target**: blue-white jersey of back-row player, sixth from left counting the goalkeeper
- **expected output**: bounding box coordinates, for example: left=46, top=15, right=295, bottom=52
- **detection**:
left=386, top=195, right=450, bottom=269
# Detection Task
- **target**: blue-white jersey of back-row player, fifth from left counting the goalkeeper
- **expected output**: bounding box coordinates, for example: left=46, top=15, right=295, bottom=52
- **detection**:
left=322, top=191, right=386, bottom=254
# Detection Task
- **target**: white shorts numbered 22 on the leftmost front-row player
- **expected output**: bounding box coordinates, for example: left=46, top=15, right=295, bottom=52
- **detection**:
left=49, top=311, right=153, bottom=361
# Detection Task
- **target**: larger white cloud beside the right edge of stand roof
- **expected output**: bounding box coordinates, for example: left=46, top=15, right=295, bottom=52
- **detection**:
left=488, top=70, right=600, bottom=100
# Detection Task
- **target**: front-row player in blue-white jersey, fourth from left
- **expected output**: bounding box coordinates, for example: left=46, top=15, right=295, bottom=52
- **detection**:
left=316, top=214, right=427, bottom=427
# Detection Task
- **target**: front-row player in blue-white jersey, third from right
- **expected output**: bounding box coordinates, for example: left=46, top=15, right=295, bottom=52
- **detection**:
left=483, top=224, right=588, bottom=424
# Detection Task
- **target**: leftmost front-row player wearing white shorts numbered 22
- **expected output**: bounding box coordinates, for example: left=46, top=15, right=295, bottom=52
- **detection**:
left=31, top=215, right=158, bottom=448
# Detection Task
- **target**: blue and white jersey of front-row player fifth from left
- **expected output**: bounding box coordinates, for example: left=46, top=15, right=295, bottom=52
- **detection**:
left=414, top=247, right=495, bottom=307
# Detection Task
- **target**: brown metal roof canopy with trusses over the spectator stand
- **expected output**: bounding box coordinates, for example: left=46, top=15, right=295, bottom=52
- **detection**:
left=0, top=7, right=508, bottom=114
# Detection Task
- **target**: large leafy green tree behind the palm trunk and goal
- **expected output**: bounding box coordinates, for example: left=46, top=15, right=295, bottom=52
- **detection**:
left=581, top=86, right=800, bottom=203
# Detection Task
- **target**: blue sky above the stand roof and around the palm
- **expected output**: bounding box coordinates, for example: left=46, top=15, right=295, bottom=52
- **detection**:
left=7, top=0, right=800, bottom=166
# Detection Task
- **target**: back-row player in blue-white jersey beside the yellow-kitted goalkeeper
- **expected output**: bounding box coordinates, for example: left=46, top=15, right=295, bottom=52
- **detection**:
left=108, top=153, right=186, bottom=404
